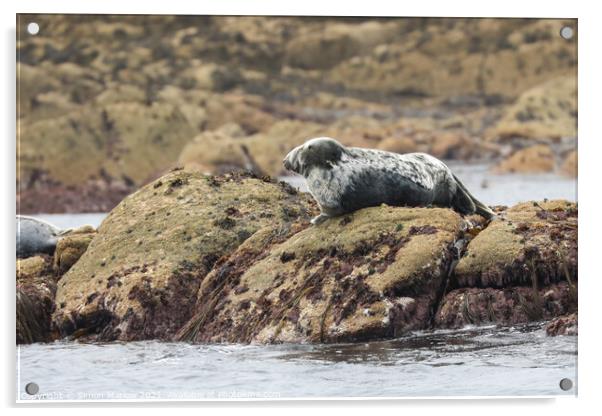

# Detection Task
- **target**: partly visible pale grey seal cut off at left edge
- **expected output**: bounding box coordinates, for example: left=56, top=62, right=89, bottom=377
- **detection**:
left=17, top=215, right=71, bottom=258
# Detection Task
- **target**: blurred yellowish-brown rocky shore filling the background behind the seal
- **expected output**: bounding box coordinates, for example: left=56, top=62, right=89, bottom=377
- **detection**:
left=17, top=15, right=577, bottom=214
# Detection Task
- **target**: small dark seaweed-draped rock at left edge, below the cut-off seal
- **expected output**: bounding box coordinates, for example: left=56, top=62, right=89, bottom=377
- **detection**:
left=16, top=255, right=58, bottom=344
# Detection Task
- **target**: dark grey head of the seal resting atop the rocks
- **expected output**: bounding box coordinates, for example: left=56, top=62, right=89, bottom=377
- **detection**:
left=283, top=137, right=346, bottom=176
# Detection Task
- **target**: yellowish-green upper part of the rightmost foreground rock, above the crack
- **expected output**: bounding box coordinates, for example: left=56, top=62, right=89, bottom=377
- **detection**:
left=454, top=200, right=578, bottom=288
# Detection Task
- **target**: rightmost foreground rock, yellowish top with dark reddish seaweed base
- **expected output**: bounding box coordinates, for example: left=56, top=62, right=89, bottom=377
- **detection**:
left=435, top=200, right=578, bottom=328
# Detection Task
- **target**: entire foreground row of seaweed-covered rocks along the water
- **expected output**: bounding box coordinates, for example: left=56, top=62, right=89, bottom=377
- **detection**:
left=17, top=169, right=578, bottom=343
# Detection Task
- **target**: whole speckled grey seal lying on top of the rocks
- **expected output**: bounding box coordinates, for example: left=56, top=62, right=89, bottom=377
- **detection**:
left=283, top=137, right=495, bottom=225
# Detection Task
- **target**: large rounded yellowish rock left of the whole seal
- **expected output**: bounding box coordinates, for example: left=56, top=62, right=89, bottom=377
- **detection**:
left=53, top=170, right=315, bottom=340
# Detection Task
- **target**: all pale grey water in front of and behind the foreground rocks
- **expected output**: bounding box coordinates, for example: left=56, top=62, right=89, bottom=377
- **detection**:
left=17, top=165, right=577, bottom=400
